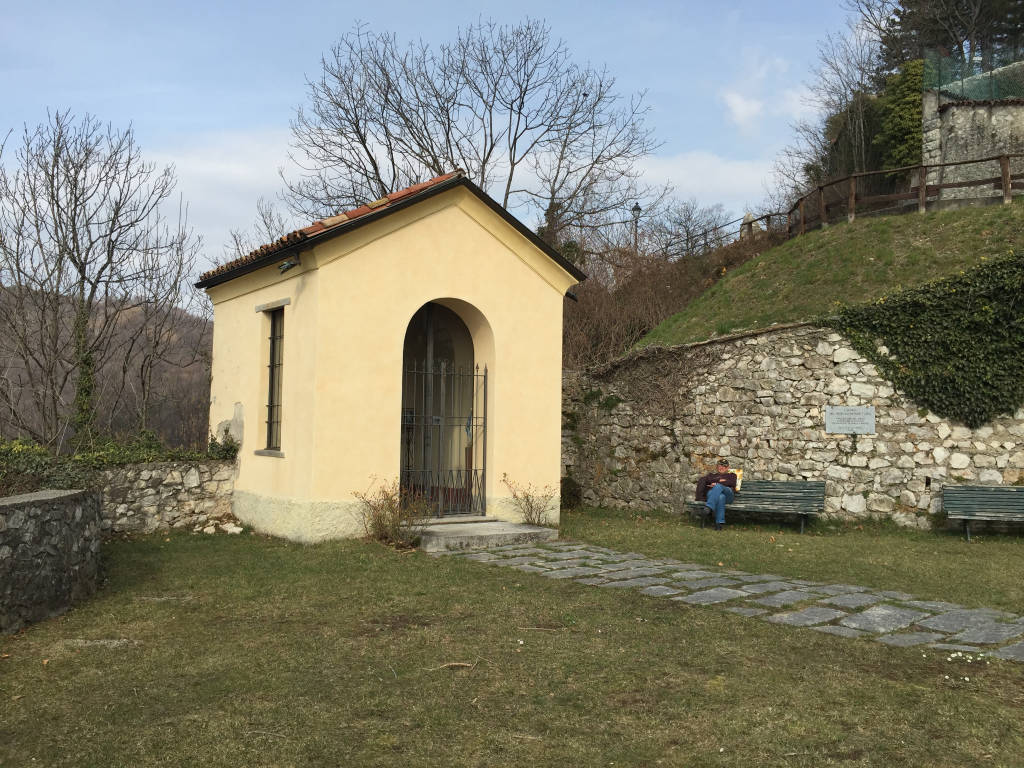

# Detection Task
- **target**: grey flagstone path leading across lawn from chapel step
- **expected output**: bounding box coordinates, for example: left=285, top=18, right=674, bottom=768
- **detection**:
left=437, top=541, right=1024, bottom=662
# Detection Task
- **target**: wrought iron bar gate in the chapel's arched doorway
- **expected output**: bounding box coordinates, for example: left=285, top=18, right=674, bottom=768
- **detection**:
left=400, top=357, right=487, bottom=517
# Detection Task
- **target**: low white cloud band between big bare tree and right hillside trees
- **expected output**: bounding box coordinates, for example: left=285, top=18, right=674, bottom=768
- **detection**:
left=643, top=151, right=771, bottom=217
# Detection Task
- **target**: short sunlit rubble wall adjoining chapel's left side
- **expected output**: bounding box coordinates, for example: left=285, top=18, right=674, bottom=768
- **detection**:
left=102, top=461, right=235, bottom=534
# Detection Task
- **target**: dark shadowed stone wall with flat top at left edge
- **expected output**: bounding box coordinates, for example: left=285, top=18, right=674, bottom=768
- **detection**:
left=0, top=490, right=100, bottom=632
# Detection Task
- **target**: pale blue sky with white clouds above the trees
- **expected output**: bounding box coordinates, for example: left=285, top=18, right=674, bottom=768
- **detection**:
left=0, top=0, right=845, bottom=270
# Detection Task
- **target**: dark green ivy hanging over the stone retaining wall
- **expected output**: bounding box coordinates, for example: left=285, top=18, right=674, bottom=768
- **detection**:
left=822, top=251, right=1024, bottom=428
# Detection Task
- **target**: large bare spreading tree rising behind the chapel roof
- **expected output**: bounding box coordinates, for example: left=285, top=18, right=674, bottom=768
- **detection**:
left=286, top=20, right=655, bottom=244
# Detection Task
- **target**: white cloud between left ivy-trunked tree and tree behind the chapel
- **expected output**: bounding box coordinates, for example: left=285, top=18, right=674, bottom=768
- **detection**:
left=146, top=131, right=290, bottom=262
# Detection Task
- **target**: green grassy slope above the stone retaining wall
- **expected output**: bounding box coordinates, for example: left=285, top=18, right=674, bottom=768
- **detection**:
left=640, top=199, right=1024, bottom=346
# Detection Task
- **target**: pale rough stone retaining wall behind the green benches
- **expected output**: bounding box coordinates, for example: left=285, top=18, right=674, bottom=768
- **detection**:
left=562, top=326, right=1024, bottom=527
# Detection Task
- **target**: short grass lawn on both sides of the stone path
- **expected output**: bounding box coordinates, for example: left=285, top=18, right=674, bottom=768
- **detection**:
left=0, top=520, right=1024, bottom=768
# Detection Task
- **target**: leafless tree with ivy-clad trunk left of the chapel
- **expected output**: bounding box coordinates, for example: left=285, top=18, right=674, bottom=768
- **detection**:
left=0, top=112, right=198, bottom=450
